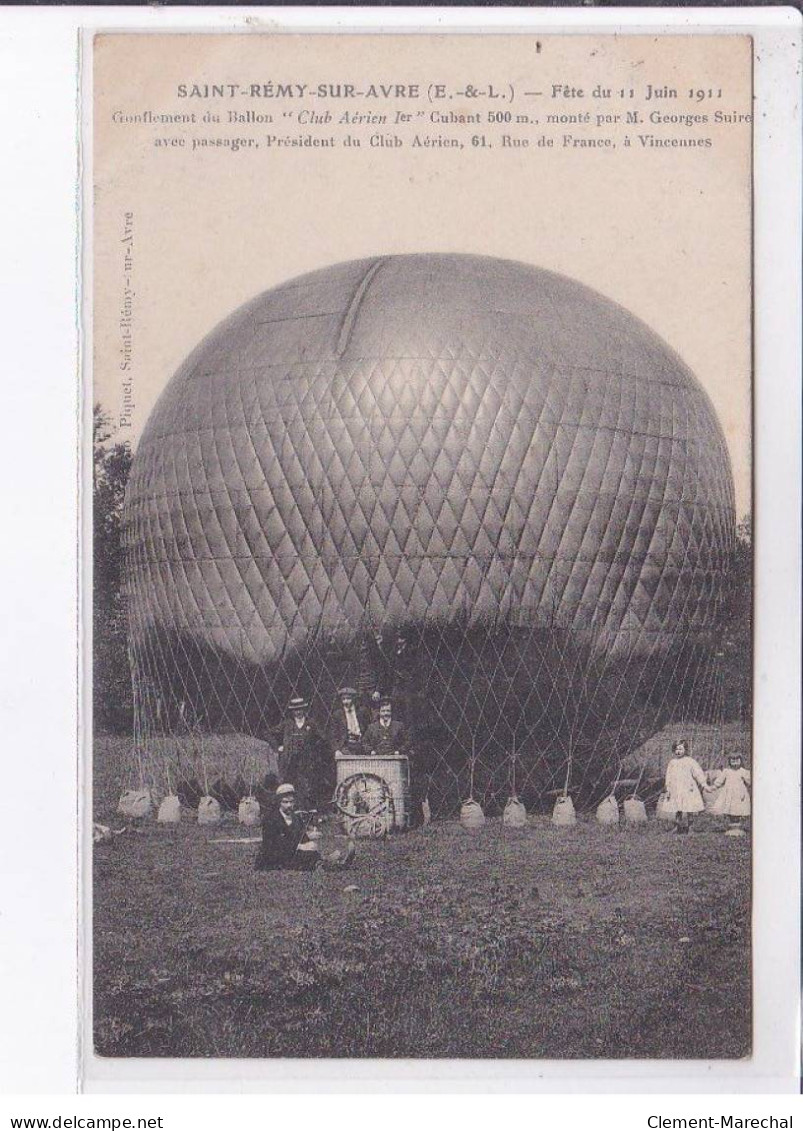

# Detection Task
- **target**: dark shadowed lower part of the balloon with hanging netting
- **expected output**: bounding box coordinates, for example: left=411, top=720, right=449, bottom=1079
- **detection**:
left=122, top=601, right=737, bottom=817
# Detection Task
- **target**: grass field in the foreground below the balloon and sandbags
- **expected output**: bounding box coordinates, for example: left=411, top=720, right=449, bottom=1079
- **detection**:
left=94, top=740, right=750, bottom=1059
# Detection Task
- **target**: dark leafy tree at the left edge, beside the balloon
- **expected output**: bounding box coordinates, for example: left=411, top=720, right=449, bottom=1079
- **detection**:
left=93, top=405, right=133, bottom=732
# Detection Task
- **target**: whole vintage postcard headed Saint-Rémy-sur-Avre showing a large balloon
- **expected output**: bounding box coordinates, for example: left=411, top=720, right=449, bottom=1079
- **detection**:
left=88, top=32, right=761, bottom=1061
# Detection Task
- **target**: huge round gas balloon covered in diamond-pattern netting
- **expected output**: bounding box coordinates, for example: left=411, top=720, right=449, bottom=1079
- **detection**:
left=124, top=256, right=734, bottom=811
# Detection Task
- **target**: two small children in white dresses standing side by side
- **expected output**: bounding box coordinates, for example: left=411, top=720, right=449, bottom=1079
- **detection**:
left=664, top=739, right=750, bottom=834
